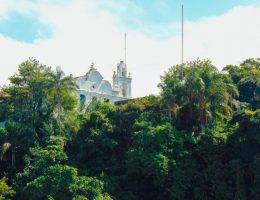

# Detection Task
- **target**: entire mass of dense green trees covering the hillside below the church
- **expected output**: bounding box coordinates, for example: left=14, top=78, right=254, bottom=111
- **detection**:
left=0, top=59, right=260, bottom=200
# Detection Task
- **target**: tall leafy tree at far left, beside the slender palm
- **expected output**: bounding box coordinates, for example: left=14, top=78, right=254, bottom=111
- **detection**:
left=2, top=59, right=51, bottom=167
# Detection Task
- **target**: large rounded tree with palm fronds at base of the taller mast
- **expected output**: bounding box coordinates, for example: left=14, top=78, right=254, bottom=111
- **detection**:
left=159, top=60, right=238, bottom=131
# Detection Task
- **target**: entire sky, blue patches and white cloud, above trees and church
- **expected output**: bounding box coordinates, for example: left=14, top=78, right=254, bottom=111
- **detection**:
left=0, top=0, right=260, bottom=97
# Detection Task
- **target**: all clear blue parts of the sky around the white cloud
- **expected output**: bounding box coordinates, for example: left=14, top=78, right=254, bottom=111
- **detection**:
left=0, top=0, right=260, bottom=43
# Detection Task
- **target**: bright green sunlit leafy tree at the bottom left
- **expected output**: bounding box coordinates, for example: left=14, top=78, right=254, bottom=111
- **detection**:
left=15, top=137, right=111, bottom=199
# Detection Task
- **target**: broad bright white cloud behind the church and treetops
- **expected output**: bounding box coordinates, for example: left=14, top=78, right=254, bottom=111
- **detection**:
left=0, top=0, right=260, bottom=97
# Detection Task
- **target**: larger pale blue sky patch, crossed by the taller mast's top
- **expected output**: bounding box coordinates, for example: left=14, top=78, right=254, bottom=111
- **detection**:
left=98, top=0, right=260, bottom=39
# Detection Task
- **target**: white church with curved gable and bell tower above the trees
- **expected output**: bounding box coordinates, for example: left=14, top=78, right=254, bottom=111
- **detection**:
left=76, top=61, right=132, bottom=104
